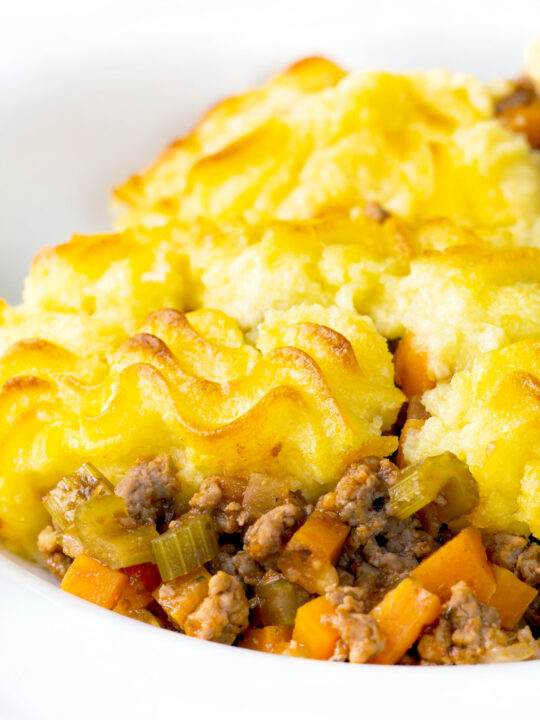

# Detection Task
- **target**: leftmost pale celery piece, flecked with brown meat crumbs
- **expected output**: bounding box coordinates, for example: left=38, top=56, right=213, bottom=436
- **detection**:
left=43, top=463, right=114, bottom=530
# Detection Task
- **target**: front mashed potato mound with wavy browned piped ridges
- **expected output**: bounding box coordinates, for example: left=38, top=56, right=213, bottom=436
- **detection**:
left=0, top=307, right=403, bottom=553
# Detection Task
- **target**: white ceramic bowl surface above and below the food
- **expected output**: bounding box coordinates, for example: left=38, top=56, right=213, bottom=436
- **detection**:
left=0, top=0, right=540, bottom=720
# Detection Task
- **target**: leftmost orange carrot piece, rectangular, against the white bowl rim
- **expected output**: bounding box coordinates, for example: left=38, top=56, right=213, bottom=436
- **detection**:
left=60, top=553, right=128, bottom=610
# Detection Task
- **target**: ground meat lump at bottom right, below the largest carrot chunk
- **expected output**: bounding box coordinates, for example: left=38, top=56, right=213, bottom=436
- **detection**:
left=418, top=582, right=537, bottom=665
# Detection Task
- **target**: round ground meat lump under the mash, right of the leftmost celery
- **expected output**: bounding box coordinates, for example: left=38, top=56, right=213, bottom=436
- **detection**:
left=115, top=455, right=180, bottom=528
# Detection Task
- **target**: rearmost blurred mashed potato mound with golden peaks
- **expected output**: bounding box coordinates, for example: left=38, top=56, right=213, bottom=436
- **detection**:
left=117, top=61, right=540, bottom=244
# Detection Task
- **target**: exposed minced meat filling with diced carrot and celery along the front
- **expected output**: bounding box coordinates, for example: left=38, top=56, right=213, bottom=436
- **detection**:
left=39, top=456, right=540, bottom=665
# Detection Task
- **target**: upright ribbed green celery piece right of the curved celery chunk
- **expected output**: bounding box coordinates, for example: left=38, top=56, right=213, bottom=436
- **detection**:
left=152, top=513, right=219, bottom=581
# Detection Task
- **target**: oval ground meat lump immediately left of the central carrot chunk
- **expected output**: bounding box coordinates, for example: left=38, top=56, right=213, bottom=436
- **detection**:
left=244, top=503, right=305, bottom=567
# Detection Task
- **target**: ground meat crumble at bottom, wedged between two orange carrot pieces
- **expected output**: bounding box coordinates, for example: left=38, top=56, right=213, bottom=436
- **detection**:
left=324, top=587, right=385, bottom=663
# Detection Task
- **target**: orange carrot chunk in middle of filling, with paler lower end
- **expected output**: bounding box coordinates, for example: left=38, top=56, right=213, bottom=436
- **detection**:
left=278, top=510, right=349, bottom=595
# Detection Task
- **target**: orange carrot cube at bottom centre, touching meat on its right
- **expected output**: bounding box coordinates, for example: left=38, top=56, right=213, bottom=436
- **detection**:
left=292, top=597, right=339, bottom=660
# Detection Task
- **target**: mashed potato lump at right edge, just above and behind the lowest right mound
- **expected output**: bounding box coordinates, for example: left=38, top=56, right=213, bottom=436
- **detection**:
left=374, top=241, right=540, bottom=380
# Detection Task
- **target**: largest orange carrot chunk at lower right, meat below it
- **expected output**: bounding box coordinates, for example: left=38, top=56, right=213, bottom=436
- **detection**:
left=411, top=526, right=496, bottom=603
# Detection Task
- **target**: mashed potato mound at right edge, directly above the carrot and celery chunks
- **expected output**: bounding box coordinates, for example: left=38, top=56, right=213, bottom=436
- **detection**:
left=404, top=340, right=540, bottom=536
